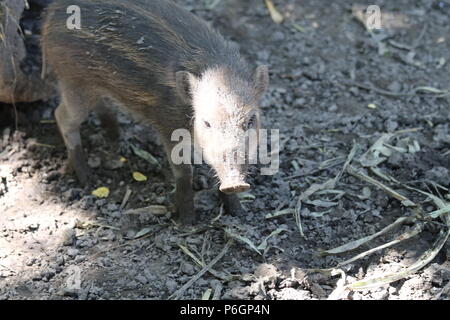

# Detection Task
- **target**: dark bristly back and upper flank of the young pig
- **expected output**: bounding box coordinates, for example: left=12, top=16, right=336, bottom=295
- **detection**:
left=42, top=0, right=239, bottom=105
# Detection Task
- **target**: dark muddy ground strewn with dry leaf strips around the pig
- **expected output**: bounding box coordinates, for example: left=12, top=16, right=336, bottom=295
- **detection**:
left=0, top=0, right=450, bottom=300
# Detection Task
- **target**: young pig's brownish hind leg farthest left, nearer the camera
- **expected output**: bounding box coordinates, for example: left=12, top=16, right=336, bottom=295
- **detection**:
left=55, top=81, right=97, bottom=185
